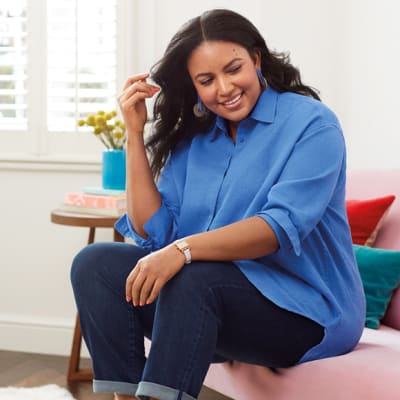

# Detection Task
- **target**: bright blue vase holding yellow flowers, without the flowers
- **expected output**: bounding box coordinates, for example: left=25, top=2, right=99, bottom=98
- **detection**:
left=102, top=149, right=126, bottom=190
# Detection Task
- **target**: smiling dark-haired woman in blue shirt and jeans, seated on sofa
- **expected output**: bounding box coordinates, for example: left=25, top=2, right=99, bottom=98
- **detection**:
left=72, top=10, right=365, bottom=400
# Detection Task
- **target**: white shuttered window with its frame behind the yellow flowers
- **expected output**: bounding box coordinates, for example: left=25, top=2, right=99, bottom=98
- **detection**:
left=0, top=0, right=135, bottom=159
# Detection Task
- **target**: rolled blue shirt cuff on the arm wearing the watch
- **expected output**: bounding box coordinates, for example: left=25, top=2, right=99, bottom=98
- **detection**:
left=257, top=209, right=301, bottom=256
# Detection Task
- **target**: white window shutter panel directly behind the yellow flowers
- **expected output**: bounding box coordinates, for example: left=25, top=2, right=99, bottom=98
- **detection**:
left=47, top=0, right=116, bottom=132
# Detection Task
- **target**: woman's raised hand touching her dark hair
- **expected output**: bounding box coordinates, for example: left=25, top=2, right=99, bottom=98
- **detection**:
left=118, top=73, right=160, bottom=137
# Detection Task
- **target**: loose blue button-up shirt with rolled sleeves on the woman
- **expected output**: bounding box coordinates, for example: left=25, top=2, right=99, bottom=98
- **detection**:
left=116, top=87, right=365, bottom=362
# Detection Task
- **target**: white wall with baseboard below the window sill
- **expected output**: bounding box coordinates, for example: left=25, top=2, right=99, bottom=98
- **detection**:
left=0, top=163, right=112, bottom=354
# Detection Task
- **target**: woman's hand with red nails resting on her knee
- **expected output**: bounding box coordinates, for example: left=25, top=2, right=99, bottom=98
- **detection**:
left=125, top=244, right=185, bottom=306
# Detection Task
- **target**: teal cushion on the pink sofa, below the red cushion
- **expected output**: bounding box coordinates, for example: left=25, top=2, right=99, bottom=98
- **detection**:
left=353, top=245, right=400, bottom=329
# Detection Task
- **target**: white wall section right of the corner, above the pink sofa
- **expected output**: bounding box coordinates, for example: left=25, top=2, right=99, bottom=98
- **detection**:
left=341, top=0, right=400, bottom=168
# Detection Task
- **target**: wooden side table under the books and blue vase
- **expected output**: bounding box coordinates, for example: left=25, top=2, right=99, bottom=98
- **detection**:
left=50, top=209, right=124, bottom=382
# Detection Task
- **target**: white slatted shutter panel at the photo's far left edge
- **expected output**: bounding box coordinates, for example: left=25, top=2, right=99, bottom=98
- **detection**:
left=0, top=0, right=27, bottom=130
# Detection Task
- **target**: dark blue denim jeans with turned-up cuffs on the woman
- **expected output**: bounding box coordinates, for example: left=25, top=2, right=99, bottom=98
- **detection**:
left=71, top=243, right=324, bottom=400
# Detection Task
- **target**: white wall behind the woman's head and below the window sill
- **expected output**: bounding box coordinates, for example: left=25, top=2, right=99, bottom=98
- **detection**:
left=0, top=0, right=400, bottom=354
